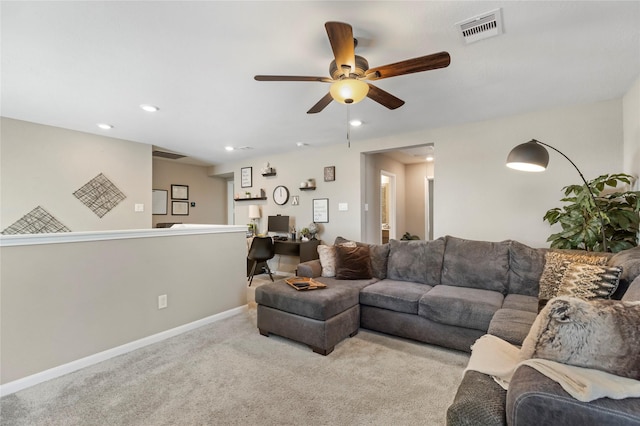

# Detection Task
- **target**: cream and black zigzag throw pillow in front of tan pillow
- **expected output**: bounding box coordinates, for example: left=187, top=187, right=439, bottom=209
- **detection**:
left=558, top=263, right=622, bottom=300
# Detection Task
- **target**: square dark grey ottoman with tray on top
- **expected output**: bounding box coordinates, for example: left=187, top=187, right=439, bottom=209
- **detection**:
left=256, top=278, right=376, bottom=355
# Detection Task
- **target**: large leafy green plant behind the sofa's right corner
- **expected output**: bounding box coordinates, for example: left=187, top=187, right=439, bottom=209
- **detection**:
left=544, top=173, right=640, bottom=253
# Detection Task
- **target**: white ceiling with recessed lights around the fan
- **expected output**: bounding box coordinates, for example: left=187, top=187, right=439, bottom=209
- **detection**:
left=0, top=1, right=640, bottom=164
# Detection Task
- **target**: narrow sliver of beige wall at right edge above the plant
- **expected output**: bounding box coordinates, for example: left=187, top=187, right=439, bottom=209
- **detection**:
left=622, top=77, right=640, bottom=190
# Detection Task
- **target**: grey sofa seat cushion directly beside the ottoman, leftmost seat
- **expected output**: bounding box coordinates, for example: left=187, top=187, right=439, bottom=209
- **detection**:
left=360, top=279, right=432, bottom=315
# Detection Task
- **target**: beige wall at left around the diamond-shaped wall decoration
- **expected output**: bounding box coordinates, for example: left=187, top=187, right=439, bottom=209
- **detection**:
left=0, top=118, right=151, bottom=231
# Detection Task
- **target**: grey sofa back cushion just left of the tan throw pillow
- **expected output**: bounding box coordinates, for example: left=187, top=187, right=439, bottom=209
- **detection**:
left=509, top=241, right=547, bottom=297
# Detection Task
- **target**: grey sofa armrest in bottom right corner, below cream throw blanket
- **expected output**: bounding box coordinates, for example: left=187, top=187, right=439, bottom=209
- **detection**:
left=506, top=365, right=640, bottom=426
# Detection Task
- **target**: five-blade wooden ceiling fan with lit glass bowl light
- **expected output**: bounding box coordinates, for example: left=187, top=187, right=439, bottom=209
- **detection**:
left=254, top=22, right=451, bottom=114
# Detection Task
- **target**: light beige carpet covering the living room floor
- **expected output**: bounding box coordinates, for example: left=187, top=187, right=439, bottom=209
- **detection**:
left=0, top=281, right=468, bottom=426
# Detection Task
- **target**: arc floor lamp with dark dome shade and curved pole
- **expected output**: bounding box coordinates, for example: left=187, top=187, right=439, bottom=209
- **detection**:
left=507, top=139, right=607, bottom=251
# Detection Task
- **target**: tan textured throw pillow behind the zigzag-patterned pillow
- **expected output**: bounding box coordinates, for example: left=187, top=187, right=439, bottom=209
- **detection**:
left=538, top=251, right=608, bottom=306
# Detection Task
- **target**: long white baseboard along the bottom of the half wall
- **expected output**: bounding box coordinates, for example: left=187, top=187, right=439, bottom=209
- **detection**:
left=0, top=305, right=247, bottom=396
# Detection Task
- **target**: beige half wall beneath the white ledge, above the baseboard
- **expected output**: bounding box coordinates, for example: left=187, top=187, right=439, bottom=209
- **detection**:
left=0, top=230, right=247, bottom=384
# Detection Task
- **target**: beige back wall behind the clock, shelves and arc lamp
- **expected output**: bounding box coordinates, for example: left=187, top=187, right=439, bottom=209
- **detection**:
left=211, top=99, right=623, bottom=247
